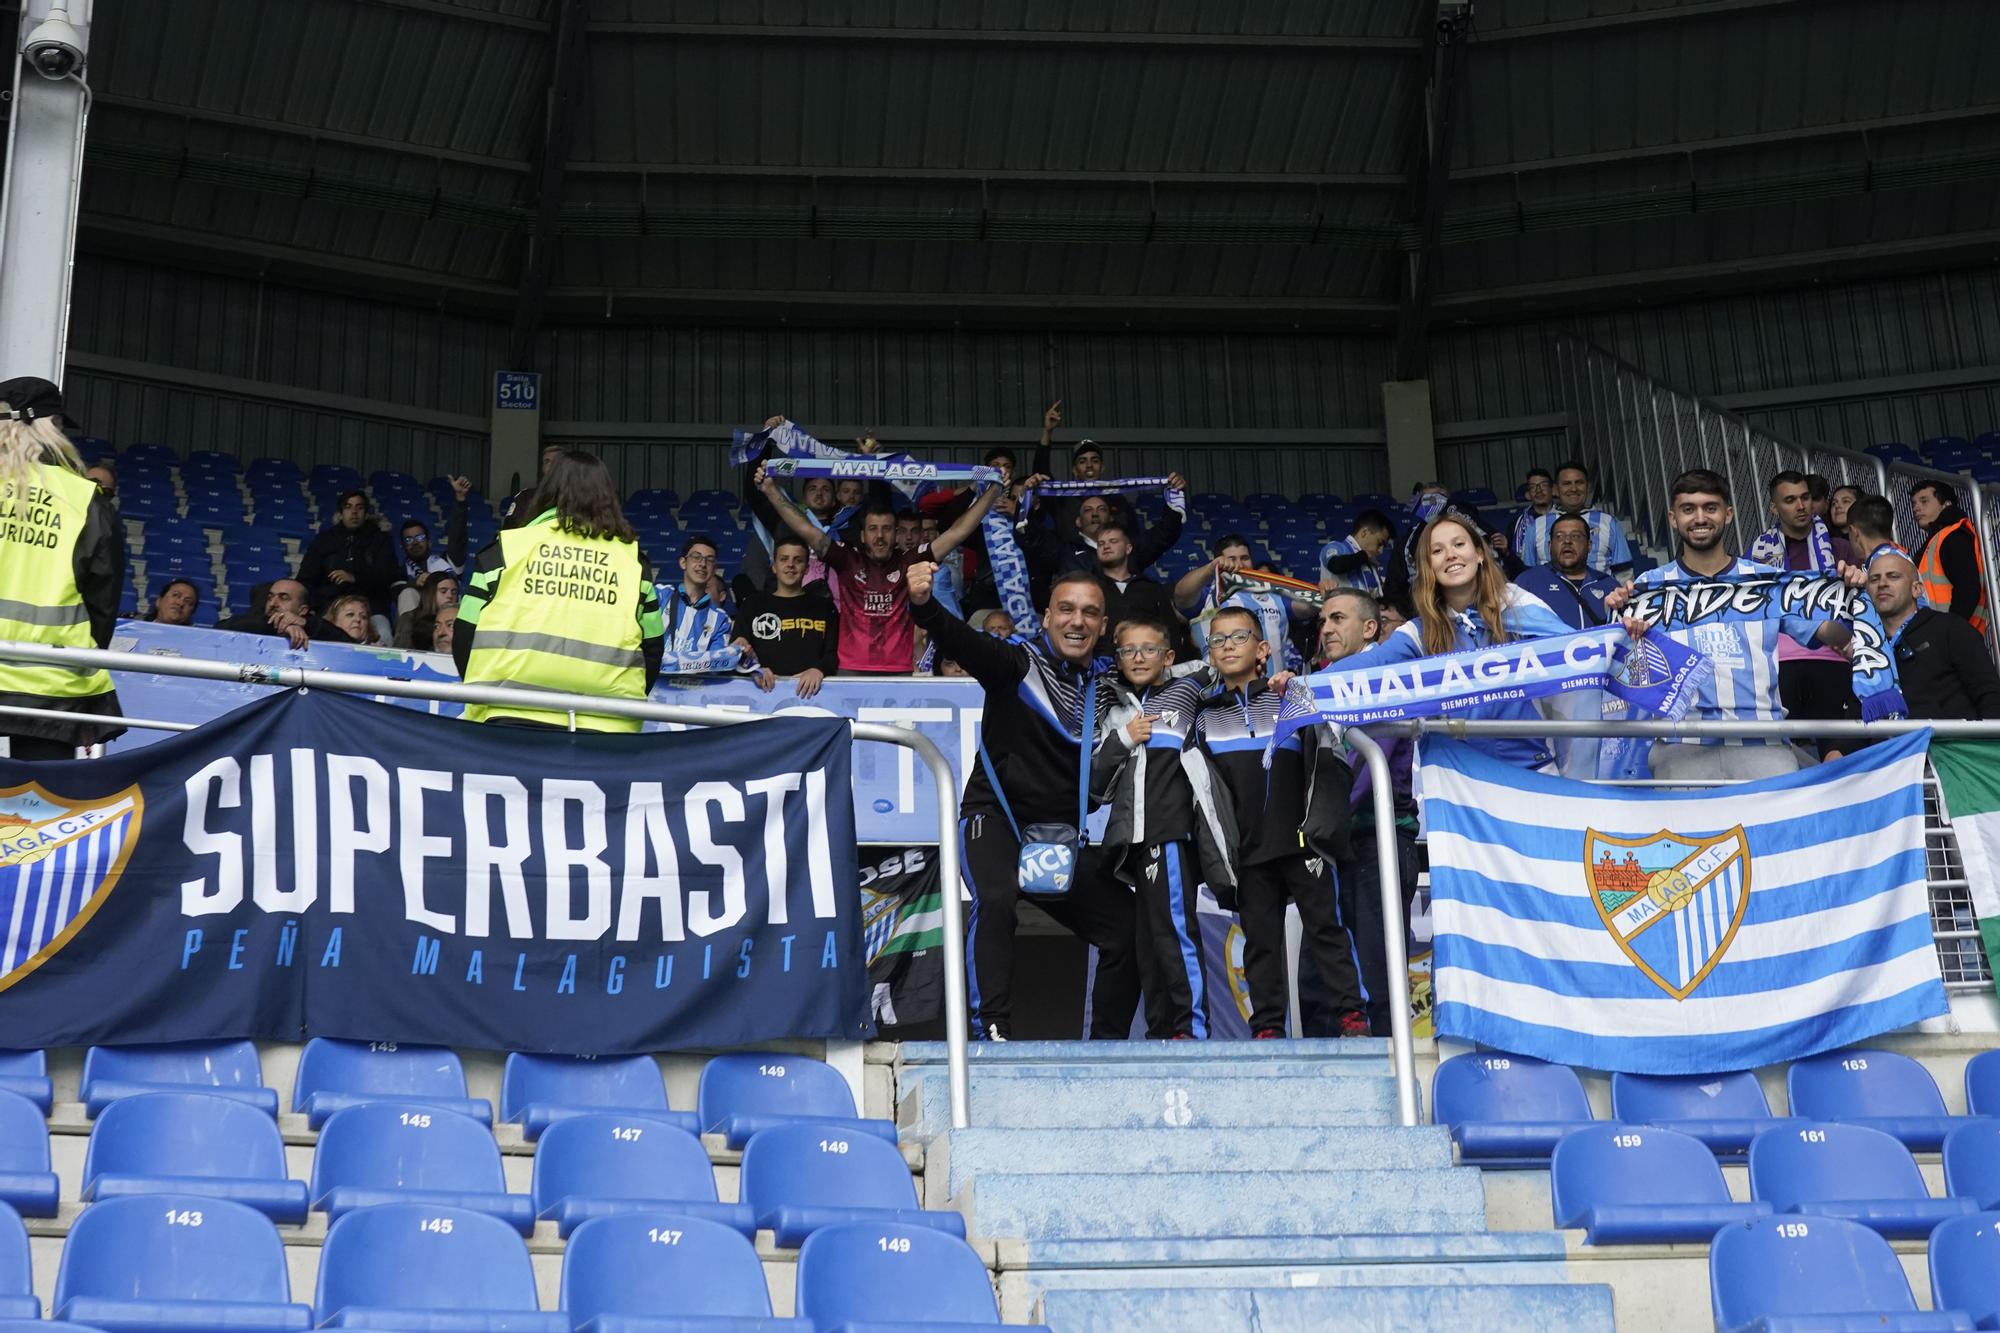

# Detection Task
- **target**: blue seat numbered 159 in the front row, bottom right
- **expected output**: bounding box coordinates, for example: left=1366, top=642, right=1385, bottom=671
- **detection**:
left=1708, top=1217, right=1972, bottom=1333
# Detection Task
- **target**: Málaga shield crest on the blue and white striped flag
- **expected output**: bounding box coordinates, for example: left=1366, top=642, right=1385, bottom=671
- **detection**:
left=1584, top=825, right=1750, bottom=999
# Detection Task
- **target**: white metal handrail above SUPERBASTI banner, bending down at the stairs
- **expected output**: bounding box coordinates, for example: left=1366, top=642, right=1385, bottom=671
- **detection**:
left=0, top=640, right=972, bottom=1129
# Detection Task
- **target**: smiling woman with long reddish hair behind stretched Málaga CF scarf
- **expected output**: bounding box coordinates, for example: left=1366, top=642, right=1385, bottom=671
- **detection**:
left=1334, top=512, right=1644, bottom=771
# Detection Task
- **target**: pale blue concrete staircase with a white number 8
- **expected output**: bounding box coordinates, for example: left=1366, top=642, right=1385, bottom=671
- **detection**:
left=896, top=1041, right=1612, bottom=1333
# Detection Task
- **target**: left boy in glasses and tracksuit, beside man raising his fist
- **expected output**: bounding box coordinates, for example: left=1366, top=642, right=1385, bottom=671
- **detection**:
left=1090, top=616, right=1236, bottom=1039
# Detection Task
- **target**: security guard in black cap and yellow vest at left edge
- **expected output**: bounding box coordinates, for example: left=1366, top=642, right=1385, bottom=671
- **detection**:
left=0, top=378, right=126, bottom=759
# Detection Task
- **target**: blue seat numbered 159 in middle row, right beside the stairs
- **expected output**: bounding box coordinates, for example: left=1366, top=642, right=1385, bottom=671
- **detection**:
left=1550, top=1125, right=1772, bottom=1245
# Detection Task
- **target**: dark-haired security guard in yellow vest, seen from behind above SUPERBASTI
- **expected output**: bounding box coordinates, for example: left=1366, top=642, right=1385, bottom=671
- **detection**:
left=452, top=450, right=666, bottom=731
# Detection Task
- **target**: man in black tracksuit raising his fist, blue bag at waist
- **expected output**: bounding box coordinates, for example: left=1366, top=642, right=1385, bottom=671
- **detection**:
left=904, top=560, right=1138, bottom=1041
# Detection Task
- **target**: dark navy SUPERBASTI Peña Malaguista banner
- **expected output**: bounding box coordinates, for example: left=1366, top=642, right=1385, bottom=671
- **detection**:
left=0, top=691, right=870, bottom=1055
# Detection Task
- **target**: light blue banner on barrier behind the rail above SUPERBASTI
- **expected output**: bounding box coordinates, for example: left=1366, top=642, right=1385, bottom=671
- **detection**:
left=110, top=620, right=986, bottom=843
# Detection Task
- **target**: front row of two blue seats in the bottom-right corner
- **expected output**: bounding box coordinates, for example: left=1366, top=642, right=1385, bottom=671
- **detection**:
left=1708, top=1213, right=2000, bottom=1333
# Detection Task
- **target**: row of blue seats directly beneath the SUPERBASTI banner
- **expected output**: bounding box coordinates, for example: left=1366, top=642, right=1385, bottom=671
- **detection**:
left=0, top=1037, right=896, bottom=1147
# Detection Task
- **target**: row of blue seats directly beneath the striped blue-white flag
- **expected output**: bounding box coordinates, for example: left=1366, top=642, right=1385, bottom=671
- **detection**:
left=1432, top=1049, right=2000, bottom=1167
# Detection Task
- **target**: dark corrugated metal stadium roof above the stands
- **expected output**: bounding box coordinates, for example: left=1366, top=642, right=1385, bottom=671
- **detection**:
left=43, top=0, right=2000, bottom=342
